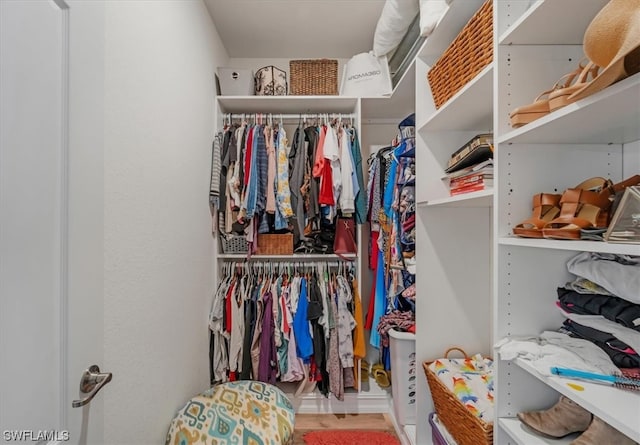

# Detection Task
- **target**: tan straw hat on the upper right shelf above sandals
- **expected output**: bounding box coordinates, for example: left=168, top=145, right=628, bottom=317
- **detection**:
left=570, top=0, right=640, bottom=101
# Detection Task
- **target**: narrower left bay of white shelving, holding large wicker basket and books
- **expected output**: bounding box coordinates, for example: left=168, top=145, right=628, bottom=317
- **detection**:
left=416, top=0, right=495, bottom=444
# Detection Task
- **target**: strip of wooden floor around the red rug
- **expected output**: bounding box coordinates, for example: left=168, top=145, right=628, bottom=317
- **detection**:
left=293, top=413, right=396, bottom=445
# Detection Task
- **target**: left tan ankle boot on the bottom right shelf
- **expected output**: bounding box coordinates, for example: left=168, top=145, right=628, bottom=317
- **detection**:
left=518, top=396, right=592, bottom=443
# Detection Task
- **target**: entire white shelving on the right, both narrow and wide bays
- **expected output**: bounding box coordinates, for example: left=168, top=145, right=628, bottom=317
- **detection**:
left=414, top=0, right=640, bottom=445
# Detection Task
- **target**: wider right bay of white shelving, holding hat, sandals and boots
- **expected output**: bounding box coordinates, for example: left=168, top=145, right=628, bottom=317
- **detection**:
left=492, top=0, right=640, bottom=445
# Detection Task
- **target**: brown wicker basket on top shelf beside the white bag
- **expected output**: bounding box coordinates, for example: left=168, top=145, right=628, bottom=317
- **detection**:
left=289, top=59, right=338, bottom=96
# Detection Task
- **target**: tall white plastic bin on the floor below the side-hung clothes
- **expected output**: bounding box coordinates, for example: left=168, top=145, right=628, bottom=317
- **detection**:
left=389, top=329, right=418, bottom=426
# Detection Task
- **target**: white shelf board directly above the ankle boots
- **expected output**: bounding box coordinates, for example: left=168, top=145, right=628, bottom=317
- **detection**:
left=514, top=359, right=640, bottom=442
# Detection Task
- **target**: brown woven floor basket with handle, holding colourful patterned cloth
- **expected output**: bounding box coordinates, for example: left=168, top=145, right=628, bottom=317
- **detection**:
left=422, top=348, right=493, bottom=445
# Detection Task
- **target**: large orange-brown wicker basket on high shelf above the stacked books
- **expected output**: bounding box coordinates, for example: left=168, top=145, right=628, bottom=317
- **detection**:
left=427, top=0, right=493, bottom=108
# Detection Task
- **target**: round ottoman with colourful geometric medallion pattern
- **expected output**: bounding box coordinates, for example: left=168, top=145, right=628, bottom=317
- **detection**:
left=165, top=380, right=295, bottom=445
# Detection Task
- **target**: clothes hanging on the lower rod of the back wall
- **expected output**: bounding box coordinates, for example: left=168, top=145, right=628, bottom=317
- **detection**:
left=209, top=262, right=362, bottom=400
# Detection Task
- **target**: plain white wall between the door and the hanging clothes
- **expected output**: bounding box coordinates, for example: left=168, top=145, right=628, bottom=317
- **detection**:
left=103, top=0, right=228, bottom=444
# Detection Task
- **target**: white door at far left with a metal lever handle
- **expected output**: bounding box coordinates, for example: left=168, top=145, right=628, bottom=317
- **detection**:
left=0, top=0, right=105, bottom=444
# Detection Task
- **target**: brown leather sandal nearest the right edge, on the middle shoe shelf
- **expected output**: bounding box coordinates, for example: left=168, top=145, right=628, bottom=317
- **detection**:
left=542, top=175, right=640, bottom=240
